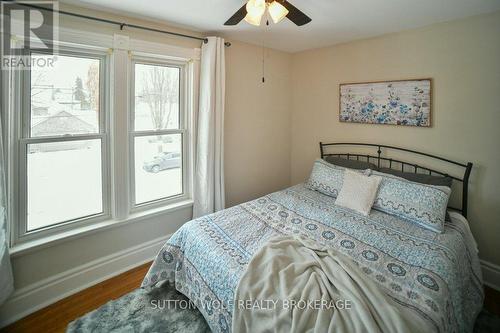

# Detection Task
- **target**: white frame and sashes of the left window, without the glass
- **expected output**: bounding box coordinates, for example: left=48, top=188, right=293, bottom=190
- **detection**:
left=11, top=45, right=111, bottom=244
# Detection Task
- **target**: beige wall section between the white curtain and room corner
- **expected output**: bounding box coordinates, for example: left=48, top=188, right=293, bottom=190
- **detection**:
left=224, top=41, right=291, bottom=207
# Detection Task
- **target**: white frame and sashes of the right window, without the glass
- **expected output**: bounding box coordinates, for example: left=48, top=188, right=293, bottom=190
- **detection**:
left=128, top=53, right=194, bottom=210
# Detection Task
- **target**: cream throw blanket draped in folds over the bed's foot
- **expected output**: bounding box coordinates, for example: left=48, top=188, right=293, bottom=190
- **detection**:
left=232, top=236, right=432, bottom=333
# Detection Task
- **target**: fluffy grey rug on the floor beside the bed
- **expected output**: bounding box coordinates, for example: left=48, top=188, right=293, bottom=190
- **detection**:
left=67, top=284, right=500, bottom=333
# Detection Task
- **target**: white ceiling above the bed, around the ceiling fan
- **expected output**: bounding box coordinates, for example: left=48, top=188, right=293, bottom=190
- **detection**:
left=62, top=0, right=500, bottom=52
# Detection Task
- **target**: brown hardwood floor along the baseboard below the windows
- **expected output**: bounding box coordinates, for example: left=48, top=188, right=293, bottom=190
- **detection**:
left=0, top=263, right=500, bottom=333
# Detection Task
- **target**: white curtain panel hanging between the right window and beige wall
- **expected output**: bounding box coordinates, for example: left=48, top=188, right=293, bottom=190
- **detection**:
left=193, top=37, right=226, bottom=218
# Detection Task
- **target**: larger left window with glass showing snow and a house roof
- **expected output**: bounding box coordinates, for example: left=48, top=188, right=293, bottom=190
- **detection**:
left=12, top=50, right=109, bottom=238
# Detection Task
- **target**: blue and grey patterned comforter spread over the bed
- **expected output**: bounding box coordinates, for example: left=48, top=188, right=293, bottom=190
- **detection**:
left=142, top=185, right=484, bottom=332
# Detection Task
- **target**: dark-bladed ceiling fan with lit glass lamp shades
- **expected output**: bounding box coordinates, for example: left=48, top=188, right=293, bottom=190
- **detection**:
left=224, top=0, right=311, bottom=26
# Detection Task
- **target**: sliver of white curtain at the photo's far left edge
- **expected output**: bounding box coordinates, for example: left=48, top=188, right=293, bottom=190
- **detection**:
left=0, top=111, right=14, bottom=304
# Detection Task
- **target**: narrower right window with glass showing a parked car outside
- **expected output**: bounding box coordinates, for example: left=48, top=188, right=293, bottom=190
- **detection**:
left=131, top=59, right=186, bottom=206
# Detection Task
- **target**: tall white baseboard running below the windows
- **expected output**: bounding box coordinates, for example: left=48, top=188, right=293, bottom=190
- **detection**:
left=0, top=235, right=171, bottom=328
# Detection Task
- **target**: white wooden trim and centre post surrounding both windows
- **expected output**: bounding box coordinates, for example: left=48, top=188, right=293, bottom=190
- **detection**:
left=0, top=31, right=201, bottom=250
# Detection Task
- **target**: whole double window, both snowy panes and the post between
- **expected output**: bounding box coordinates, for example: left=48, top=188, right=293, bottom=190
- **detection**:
left=2, top=39, right=197, bottom=246
